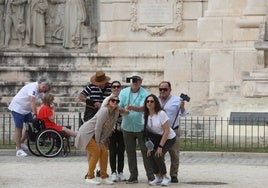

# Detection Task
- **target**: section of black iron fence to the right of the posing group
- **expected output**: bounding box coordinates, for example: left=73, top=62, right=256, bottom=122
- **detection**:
left=180, top=117, right=268, bottom=151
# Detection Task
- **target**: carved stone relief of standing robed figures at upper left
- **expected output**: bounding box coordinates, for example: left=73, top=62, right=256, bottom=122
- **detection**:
left=0, top=0, right=99, bottom=52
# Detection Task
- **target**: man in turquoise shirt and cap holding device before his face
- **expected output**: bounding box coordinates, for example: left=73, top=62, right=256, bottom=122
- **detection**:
left=119, top=76, right=154, bottom=184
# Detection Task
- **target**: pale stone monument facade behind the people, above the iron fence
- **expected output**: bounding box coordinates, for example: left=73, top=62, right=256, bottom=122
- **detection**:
left=0, top=0, right=268, bottom=117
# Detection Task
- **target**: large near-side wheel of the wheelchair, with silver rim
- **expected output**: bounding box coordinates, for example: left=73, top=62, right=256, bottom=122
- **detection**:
left=35, top=129, right=63, bottom=157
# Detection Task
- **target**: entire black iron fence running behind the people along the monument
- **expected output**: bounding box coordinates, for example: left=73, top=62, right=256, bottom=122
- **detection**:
left=0, top=113, right=268, bottom=152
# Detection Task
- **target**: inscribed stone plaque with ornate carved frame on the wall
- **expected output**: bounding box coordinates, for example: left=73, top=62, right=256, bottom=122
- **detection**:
left=131, top=0, right=183, bottom=36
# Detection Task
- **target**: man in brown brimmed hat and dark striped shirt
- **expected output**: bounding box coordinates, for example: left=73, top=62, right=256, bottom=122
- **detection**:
left=79, top=71, right=111, bottom=122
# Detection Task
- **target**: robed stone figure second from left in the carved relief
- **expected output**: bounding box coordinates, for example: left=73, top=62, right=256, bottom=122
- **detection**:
left=26, top=0, right=48, bottom=46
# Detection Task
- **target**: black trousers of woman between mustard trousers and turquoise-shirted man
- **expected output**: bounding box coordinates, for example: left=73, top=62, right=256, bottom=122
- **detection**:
left=109, top=130, right=125, bottom=174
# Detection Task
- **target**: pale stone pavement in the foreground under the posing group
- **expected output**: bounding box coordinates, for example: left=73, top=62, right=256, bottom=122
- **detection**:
left=0, top=150, right=268, bottom=188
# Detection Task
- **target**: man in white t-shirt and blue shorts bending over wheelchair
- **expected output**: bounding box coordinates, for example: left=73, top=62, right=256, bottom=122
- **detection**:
left=8, top=82, right=50, bottom=157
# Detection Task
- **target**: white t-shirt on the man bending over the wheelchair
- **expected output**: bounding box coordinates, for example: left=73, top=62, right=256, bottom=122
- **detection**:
left=8, top=82, right=44, bottom=115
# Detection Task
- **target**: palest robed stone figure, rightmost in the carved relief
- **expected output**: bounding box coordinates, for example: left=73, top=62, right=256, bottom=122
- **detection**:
left=63, top=0, right=86, bottom=48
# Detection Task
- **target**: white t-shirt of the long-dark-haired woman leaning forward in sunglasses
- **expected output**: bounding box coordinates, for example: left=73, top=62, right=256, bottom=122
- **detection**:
left=143, top=110, right=176, bottom=139
